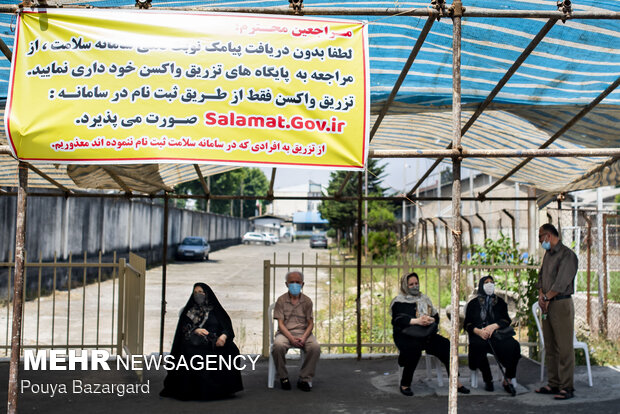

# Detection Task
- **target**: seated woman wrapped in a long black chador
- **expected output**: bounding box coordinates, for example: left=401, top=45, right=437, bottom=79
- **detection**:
left=160, top=283, right=243, bottom=400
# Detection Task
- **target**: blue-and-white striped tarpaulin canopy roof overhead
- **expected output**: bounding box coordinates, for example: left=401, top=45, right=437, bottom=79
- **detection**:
left=0, top=0, right=620, bottom=201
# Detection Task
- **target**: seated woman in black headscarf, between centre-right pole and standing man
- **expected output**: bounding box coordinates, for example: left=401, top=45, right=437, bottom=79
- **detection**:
left=465, top=276, right=521, bottom=396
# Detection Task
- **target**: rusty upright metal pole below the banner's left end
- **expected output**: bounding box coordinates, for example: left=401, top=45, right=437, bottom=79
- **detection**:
left=7, top=162, right=28, bottom=414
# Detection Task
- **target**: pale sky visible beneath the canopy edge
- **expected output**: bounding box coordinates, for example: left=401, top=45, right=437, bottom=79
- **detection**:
left=261, top=158, right=447, bottom=192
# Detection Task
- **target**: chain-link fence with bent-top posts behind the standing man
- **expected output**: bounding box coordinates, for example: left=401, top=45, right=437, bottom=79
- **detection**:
left=409, top=208, right=620, bottom=340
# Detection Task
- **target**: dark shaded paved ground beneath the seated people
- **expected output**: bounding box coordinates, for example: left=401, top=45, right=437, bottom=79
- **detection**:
left=0, top=357, right=620, bottom=414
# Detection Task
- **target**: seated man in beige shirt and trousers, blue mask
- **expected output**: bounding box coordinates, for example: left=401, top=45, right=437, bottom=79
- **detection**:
left=273, top=271, right=321, bottom=391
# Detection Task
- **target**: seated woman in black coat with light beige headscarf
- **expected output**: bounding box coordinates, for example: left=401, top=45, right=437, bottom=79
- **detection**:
left=390, top=272, right=469, bottom=397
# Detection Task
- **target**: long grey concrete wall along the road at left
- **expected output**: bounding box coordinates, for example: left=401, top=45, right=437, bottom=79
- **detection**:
left=0, top=196, right=250, bottom=297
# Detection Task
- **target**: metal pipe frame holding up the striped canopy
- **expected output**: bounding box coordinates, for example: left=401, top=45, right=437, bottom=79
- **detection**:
left=0, top=4, right=620, bottom=413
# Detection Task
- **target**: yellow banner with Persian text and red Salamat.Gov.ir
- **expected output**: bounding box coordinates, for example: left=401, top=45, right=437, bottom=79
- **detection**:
left=5, top=10, right=370, bottom=169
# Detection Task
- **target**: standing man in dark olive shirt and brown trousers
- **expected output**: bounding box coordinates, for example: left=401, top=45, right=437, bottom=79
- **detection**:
left=536, top=223, right=577, bottom=400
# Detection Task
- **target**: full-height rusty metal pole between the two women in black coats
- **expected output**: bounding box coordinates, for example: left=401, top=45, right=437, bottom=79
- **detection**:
left=448, top=0, right=463, bottom=414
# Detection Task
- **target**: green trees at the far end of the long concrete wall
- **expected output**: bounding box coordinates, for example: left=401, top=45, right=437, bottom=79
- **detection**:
left=175, top=167, right=269, bottom=217
